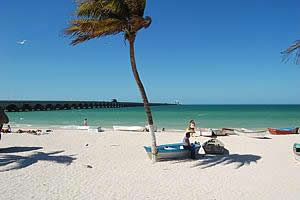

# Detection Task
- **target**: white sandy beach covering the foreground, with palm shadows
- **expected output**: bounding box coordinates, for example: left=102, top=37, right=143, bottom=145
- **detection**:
left=0, top=130, right=300, bottom=200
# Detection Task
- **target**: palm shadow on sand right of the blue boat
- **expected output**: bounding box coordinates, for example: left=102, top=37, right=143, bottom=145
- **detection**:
left=192, top=149, right=261, bottom=169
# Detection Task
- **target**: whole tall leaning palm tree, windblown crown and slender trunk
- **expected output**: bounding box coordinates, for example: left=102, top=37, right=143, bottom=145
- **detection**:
left=65, top=0, right=157, bottom=162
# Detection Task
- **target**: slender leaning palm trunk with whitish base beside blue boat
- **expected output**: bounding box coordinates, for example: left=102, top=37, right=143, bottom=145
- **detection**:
left=128, top=34, right=157, bottom=162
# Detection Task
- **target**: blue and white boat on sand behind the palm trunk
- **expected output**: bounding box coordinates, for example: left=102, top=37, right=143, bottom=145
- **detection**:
left=144, top=143, right=201, bottom=159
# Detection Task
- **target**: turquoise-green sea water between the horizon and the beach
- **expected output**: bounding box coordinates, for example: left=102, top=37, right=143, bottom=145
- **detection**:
left=4, top=105, right=300, bottom=130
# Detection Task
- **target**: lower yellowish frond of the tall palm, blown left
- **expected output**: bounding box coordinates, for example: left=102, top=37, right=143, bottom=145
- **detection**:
left=65, top=18, right=126, bottom=45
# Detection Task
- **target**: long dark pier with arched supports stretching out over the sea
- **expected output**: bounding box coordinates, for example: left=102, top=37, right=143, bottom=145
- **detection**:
left=0, top=100, right=175, bottom=112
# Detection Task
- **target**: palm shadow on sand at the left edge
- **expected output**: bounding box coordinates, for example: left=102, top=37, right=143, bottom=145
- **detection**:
left=0, top=151, right=76, bottom=172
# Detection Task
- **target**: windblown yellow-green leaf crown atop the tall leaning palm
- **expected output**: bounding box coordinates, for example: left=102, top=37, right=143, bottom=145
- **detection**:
left=65, top=0, right=151, bottom=45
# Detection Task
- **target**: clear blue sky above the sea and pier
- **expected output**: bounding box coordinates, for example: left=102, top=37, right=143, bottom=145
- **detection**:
left=0, top=0, right=300, bottom=104
